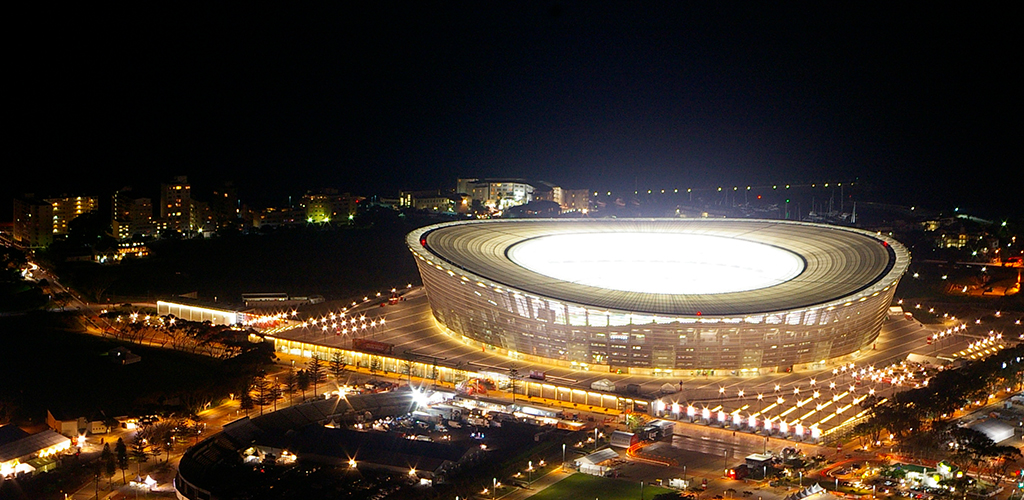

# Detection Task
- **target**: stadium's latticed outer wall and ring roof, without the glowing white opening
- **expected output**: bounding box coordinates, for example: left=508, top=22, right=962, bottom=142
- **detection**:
left=407, top=219, right=910, bottom=376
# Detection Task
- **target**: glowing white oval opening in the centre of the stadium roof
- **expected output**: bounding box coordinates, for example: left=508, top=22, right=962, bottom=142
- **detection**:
left=508, top=233, right=805, bottom=294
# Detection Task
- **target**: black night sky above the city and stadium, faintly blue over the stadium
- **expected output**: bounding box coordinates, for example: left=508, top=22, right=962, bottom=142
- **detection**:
left=8, top=1, right=1024, bottom=217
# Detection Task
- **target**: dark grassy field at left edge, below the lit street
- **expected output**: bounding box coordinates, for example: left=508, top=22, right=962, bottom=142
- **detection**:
left=0, top=313, right=245, bottom=423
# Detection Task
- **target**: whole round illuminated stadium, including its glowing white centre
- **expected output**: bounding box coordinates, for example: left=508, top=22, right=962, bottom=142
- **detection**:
left=407, top=218, right=910, bottom=375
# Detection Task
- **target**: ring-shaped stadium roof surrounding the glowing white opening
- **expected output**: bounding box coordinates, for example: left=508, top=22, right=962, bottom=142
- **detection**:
left=408, top=218, right=909, bottom=317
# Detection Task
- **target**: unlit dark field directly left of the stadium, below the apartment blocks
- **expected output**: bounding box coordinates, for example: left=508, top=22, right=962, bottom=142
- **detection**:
left=50, top=222, right=428, bottom=302
